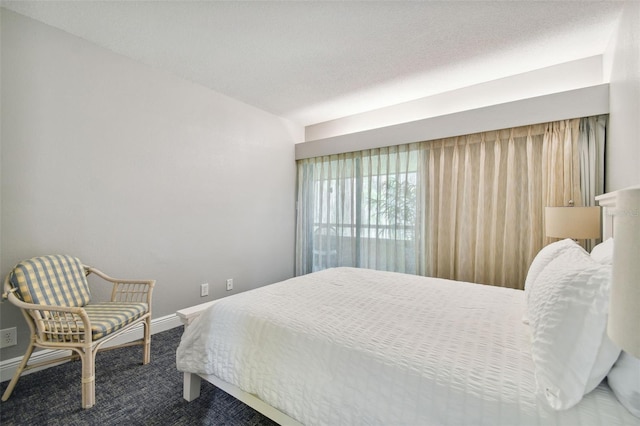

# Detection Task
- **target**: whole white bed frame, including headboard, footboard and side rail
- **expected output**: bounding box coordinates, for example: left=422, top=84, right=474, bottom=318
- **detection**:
left=176, top=186, right=640, bottom=426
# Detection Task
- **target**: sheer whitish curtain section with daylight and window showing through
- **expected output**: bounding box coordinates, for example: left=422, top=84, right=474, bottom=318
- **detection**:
left=296, top=144, right=420, bottom=275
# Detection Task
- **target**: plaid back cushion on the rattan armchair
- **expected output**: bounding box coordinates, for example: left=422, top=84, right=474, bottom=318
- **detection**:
left=10, top=255, right=91, bottom=307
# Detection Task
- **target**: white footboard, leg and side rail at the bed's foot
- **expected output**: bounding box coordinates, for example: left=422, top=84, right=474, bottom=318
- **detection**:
left=176, top=300, right=302, bottom=426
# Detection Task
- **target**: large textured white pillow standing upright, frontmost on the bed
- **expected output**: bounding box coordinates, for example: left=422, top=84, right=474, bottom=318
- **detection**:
left=528, top=244, right=620, bottom=410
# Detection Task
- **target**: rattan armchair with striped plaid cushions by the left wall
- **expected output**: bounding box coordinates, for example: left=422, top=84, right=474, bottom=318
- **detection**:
left=2, top=255, right=155, bottom=408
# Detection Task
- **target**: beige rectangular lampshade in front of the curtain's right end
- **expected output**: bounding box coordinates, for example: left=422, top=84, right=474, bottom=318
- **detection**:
left=545, top=207, right=601, bottom=240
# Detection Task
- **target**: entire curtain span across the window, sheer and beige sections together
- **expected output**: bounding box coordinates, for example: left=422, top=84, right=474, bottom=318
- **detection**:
left=296, top=117, right=606, bottom=288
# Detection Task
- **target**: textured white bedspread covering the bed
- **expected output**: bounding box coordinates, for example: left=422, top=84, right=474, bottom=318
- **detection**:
left=177, top=268, right=640, bottom=425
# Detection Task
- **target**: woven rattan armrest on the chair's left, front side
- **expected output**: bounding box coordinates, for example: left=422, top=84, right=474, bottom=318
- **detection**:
left=2, top=289, right=92, bottom=346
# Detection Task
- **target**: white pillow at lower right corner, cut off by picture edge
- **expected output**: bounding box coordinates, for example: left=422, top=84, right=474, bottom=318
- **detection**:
left=607, top=351, right=640, bottom=417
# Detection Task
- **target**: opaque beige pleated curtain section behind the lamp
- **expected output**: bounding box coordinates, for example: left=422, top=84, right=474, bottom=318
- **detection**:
left=418, top=119, right=596, bottom=288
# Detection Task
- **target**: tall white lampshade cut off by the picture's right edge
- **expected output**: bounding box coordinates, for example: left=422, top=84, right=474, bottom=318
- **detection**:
left=607, top=189, right=640, bottom=358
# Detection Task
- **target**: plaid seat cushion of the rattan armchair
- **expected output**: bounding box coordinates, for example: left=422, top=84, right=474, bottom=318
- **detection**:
left=84, top=302, right=149, bottom=340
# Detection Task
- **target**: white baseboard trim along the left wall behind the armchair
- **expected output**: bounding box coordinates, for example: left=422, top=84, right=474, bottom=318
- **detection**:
left=0, top=314, right=182, bottom=382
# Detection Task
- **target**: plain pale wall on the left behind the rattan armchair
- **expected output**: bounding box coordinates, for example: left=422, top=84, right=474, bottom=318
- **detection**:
left=0, top=9, right=303, bottom=359
